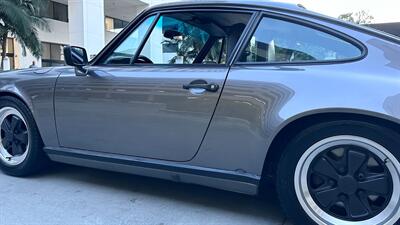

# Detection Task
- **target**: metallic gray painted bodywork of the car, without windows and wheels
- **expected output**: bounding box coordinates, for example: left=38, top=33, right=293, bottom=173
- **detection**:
left=0, top=3, right=400, bottom=194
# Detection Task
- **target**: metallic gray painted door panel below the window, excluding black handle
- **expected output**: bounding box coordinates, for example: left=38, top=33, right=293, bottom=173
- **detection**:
left=54, top=66, right=228, bottom=161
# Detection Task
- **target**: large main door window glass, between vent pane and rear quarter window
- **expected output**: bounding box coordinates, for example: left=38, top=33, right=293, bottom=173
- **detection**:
left=135, top=12, right=251, bottom=65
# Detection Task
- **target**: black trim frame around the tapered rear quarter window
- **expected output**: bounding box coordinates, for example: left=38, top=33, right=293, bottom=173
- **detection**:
left=233, top=11, right=368, bottom=66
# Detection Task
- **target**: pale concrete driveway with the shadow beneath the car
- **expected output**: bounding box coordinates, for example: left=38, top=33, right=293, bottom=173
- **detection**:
left=0, top=165, right=288, bottom=225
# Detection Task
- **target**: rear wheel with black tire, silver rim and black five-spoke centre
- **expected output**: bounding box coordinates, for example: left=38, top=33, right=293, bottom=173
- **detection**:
left=276, top=121, right=400, bottom=225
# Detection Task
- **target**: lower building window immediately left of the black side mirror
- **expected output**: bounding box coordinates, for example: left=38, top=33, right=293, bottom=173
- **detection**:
left=42, top=42, right=65, bottom=67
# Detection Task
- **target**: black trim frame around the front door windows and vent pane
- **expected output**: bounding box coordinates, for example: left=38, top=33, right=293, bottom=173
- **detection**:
left=89, top=7, right=260, bottom=68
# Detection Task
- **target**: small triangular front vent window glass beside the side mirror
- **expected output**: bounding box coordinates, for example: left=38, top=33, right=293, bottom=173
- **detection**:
left=104, top=16, right=155, bottom=65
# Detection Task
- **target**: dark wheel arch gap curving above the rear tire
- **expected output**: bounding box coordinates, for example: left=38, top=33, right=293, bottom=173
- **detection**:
left=259, top=110, right=400, bottom=192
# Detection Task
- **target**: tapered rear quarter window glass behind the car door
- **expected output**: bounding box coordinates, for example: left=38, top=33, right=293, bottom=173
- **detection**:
left=240, top=18, right=362, bottom=63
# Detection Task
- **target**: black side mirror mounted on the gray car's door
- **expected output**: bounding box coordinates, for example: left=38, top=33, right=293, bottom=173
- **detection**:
left=64, top=46, right=89, bottom=74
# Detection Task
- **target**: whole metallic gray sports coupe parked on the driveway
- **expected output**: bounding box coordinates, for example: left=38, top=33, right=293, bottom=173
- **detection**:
left=0, top=0, right=400, bottom=225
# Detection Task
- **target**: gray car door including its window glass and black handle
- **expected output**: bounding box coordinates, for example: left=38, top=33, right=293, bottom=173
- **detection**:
left=55, top=12, right=250, bottom=161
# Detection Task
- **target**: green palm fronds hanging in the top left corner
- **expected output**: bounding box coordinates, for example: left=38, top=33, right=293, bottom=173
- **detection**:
left=0, top=0, right=50, bottom=67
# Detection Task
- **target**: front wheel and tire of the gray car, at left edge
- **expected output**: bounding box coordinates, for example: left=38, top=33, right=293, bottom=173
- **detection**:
left=0, top=96, right=49, bottom=177
